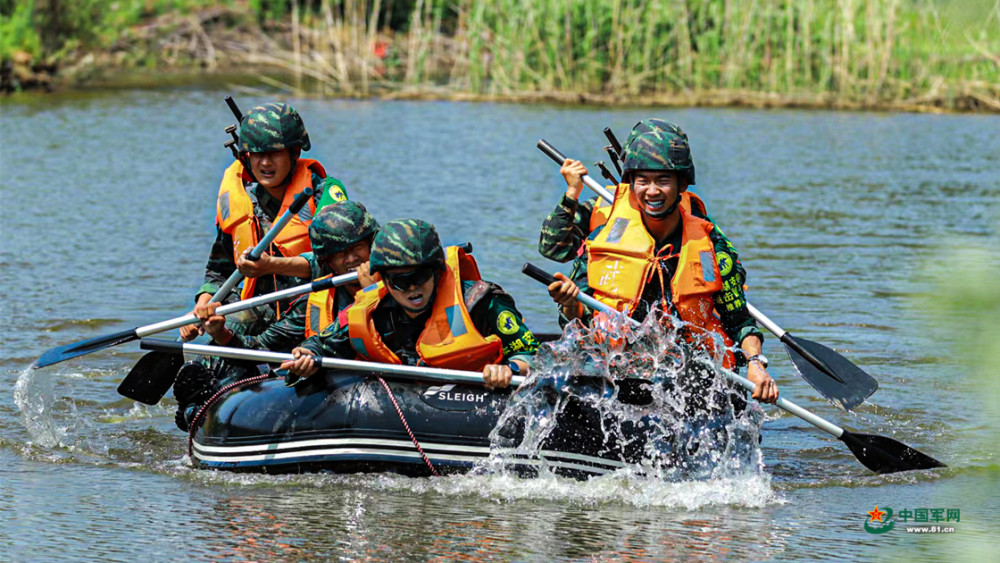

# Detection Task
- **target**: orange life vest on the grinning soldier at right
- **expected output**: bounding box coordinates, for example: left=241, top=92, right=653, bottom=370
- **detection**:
left=586, top=184, right=735, bottom=368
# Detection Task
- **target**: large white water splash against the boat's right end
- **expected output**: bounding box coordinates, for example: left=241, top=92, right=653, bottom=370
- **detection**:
left=478, top=308, right=763, bottom=482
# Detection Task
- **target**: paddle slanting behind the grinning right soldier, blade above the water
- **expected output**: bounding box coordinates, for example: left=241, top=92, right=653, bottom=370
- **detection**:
left=538, top=137, right=878, bottom=411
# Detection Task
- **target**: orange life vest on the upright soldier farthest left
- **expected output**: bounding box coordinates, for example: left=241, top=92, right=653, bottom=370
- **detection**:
left=215, top=158, right=326, bottom=299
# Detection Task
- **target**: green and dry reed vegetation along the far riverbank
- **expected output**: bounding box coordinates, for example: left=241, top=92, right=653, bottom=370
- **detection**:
left=0, top=0, right=1000, bottom=111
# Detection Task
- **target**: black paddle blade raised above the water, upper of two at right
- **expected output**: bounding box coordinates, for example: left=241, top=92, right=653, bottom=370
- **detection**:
left=782, top=333, right=878, bottom=411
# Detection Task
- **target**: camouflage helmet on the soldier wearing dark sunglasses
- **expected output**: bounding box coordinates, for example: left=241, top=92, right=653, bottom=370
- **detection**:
left=370, top=219, right=444, bottom=274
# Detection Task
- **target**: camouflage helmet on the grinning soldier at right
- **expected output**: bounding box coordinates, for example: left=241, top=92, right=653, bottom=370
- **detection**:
left=622, top=119, right=695, bottom=184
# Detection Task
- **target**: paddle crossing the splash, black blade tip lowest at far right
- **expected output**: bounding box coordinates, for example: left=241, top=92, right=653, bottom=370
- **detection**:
left=521, top=263, right=947, bottom=473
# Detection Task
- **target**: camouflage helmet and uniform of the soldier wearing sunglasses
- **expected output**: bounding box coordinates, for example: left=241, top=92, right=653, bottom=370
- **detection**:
left=302, top=219, right=538, bottom=365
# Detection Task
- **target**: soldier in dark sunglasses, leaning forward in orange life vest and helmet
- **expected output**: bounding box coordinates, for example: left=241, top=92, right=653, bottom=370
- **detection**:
left=281, top=219, right=538, bottom=388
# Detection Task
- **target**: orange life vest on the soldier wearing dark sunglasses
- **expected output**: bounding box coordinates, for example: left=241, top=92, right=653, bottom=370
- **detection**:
left=347, top=246, right=503, bottom=370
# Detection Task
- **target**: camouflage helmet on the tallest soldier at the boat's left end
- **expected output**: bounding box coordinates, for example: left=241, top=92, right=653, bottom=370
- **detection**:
left=239, top=102, right=312, bottom=152
